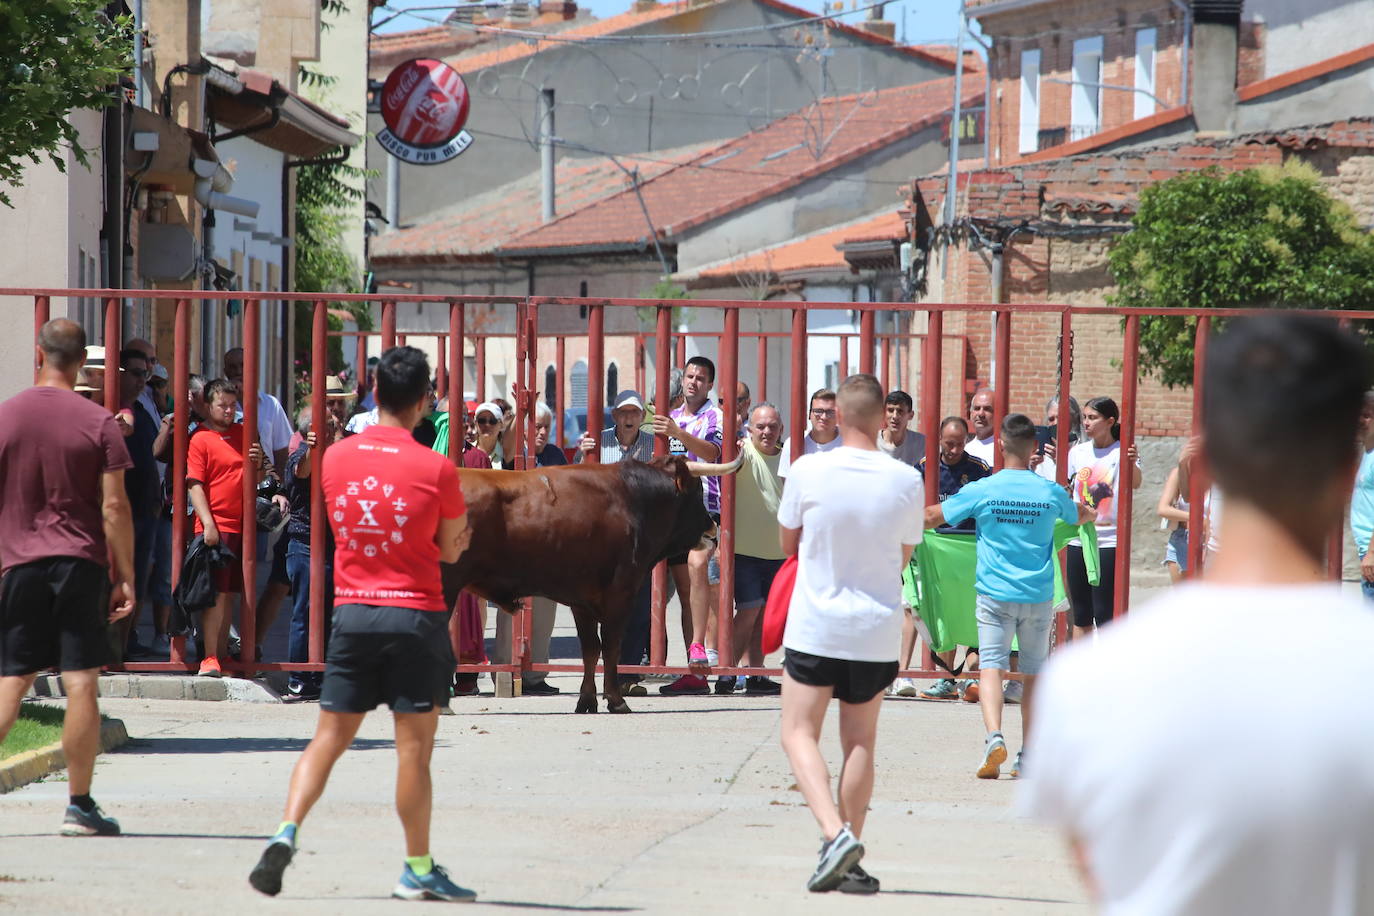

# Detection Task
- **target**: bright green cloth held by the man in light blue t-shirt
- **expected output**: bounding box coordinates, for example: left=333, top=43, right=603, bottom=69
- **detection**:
left=901, top=522, right=1102, bottom=652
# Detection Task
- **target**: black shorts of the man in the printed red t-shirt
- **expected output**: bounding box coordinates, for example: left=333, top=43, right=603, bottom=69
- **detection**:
left=320, top=604, right=455, bottom=713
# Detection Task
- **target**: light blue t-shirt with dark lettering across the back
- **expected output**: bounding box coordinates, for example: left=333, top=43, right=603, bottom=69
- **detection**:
left=943, top=468, right=1079, bottom=604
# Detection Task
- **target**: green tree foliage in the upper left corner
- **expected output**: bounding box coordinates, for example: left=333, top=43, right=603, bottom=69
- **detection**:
left=0, top=0, right=133, bottom=206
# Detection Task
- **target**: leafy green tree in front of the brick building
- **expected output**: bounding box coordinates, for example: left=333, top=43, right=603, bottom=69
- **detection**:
left=1109, top=159, right=1374, bottom=387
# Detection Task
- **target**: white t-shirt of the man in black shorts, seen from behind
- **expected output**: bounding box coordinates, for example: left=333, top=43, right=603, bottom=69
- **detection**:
left=778, top=446, right=925, bottom=662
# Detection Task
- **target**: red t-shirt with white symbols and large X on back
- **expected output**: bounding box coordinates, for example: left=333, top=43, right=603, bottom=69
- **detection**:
left=322, top=426, right=466, bottom=611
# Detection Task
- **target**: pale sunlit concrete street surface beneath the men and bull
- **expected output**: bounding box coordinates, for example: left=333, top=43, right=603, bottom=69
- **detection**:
left=0, top=692, right=1085, bottom=916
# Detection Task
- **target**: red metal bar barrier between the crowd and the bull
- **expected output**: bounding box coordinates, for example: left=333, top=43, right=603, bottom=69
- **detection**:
left=18, top=290, right=1370, bottom=686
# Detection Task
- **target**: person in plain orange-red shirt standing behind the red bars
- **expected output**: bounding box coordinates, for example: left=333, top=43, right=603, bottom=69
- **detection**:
left=185, top=379, right=262, bottom=677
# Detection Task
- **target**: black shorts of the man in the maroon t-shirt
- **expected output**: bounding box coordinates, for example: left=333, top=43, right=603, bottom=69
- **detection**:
left=0, top=556, right=110, bottom=677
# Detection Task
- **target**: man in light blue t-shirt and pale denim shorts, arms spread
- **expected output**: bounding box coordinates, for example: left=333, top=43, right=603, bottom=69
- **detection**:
left=926, top=413, right=1096, bottom=779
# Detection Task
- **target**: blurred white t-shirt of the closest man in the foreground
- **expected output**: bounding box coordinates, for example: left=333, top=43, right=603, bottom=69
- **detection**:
left=1021, top=585, right=1374, bottom=916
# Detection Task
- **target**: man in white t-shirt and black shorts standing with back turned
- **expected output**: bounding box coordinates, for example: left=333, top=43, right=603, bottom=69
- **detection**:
left=778, top=375, right=923, bottom=894
